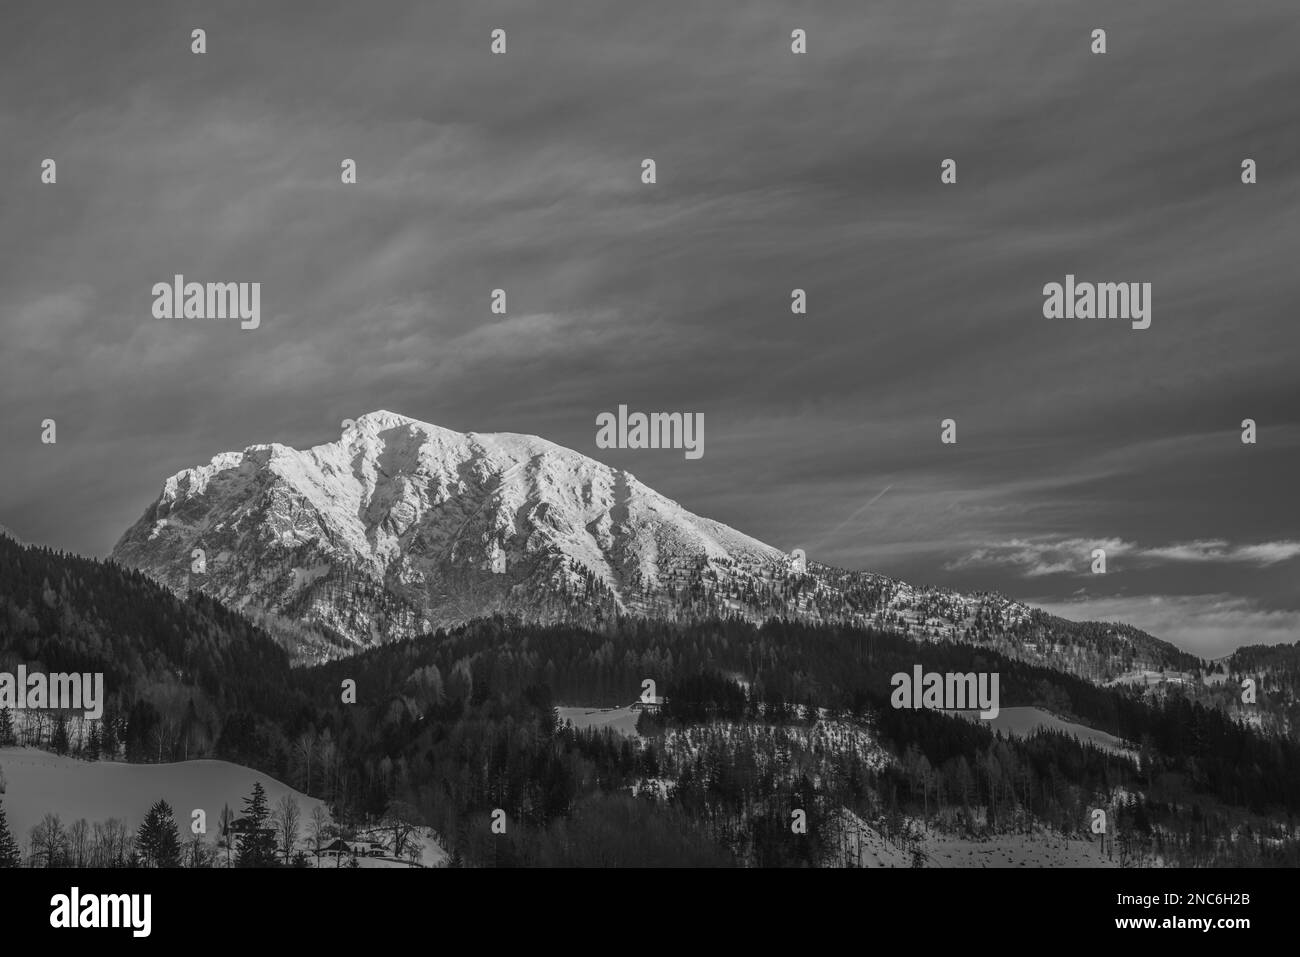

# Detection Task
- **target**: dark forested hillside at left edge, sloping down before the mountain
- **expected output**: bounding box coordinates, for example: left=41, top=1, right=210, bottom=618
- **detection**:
left=0, top=536, right=291, bottom=761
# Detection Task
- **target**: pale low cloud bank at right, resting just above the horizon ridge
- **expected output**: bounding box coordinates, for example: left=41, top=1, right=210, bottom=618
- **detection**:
left=1030, top=594, right=1300, bottom=658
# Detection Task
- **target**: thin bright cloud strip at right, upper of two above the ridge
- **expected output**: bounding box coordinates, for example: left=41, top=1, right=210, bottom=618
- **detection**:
left=945, top=538, right=1300, bottom=577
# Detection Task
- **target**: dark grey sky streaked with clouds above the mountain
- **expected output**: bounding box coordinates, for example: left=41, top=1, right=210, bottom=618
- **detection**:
left=0, top=0, right=1300, bottom=655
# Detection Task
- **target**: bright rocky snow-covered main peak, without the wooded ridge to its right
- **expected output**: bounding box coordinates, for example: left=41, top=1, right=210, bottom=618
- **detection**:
left=113, top=410, right=787, bottom=644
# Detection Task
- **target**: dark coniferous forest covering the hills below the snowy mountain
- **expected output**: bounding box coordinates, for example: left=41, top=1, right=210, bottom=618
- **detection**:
left=0, top=538, right=1300, bottom=866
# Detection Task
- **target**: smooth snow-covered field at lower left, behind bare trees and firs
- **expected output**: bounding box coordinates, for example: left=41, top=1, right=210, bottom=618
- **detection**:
left=0, top=748, right=328, bottom=844
